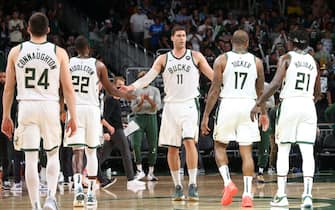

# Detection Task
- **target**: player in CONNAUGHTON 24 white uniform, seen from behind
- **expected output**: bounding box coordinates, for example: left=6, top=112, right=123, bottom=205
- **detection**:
left=1, top=13, right=77, bottom=209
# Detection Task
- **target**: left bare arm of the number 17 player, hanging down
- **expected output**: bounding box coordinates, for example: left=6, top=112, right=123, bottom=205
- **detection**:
left=201, top=55, right=227, bottom=135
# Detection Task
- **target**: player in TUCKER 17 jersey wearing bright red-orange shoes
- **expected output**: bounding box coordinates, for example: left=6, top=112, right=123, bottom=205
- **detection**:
left=201, top=30, right=267, bottom=207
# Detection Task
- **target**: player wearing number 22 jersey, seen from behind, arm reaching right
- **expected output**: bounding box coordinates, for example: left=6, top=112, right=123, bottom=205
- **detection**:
left=65, top=36, right=132, bottom=207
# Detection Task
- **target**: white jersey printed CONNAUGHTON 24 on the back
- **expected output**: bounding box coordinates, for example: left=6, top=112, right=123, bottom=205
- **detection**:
left=15, top=41, right=60, bottom=101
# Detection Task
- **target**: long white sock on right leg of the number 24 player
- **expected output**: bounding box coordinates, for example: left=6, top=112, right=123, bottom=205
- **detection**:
left=46, top=148, right=60, bottom=197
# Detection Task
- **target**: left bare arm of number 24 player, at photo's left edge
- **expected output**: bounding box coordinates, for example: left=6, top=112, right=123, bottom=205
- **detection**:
left=1, top=46, right=20, bottom=139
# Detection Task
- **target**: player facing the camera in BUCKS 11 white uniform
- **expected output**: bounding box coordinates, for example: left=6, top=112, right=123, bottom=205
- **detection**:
left=122, top=26, right=213, bottom=201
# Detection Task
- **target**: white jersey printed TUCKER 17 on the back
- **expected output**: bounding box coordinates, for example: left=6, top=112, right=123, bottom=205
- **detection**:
left=220, top=51, right=257, bottom=99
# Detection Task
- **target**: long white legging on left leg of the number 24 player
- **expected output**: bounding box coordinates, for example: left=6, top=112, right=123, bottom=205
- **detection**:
left=24, top=151, right=41, bottom=208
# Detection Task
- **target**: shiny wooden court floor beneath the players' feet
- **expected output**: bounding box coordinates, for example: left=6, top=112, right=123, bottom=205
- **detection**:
left=0, top=172, right=335, bottom=210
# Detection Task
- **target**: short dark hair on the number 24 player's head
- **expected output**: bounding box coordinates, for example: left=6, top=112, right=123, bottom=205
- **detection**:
left=28, top=12, right=49, bottom=37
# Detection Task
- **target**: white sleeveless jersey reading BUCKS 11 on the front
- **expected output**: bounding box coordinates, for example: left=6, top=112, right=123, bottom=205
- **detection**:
left=163, top=50, right=200, bottom=102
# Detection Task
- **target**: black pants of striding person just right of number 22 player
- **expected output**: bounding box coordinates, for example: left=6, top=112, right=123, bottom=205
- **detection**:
left=98, top=129, right=134, bottom=181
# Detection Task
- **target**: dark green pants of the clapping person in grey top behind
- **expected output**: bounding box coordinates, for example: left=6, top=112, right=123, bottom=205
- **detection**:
left=131, top=114, right=158, bottom=166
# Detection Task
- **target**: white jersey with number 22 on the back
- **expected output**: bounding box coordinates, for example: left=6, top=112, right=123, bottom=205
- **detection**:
left=70, top=57, right=100, bottom=106
